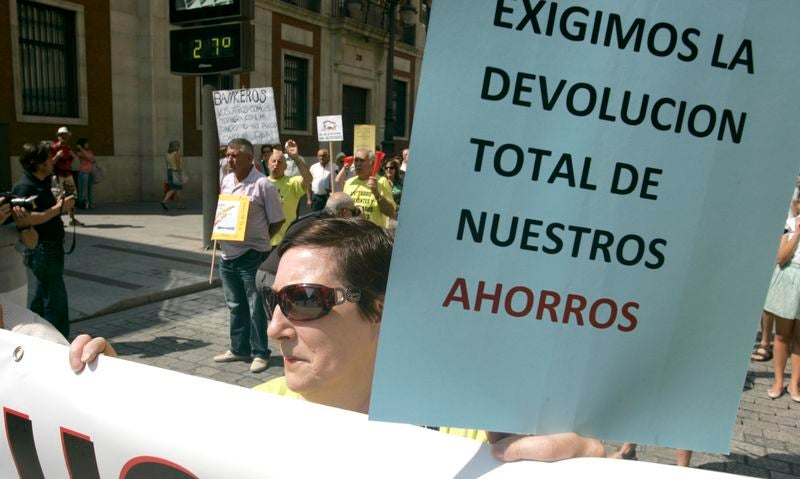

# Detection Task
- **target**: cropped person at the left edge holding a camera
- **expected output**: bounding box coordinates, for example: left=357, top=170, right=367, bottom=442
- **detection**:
left=0, top=194, right=39, bottom=305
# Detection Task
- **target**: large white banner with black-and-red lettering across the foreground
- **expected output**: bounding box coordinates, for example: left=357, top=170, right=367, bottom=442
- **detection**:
left=0, top=330, right=733, bottom=479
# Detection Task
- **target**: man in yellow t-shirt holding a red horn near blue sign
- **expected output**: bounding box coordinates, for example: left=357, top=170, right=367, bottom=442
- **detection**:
left=344, top=148, right=397, bottom=228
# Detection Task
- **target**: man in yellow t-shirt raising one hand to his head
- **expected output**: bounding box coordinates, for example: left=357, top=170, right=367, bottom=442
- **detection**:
left=267, top=140, right=312, bottom=248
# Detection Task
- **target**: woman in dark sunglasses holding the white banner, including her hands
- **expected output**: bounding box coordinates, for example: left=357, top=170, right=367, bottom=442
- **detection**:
left=70, top=218, right=605, bottom=461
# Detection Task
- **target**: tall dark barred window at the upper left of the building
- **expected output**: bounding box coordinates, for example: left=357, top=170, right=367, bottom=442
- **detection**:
left=17, top=0, right=80, bottom=118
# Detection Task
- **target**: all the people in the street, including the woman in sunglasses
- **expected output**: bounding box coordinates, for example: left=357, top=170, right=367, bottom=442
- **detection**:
left=6, top=133, right=800, bottom=466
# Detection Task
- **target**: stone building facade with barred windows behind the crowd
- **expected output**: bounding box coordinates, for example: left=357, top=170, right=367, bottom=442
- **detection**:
left=0, top=0, right=429, bottom=203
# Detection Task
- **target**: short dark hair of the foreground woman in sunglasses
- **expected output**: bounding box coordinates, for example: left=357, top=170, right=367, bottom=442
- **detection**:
left=278, top=218, right=394, bottom=322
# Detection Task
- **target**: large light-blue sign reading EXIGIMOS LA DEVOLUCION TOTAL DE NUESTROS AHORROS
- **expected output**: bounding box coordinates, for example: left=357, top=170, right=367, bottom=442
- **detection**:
left=370, top=0, right=800, bottom=451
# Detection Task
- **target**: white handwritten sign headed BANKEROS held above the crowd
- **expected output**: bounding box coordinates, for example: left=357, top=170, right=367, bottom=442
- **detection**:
left=213, top=87, right=280, bottom=145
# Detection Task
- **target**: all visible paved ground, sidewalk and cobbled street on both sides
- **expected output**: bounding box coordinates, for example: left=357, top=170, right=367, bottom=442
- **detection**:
left=42, top=202, right=800, bottom=479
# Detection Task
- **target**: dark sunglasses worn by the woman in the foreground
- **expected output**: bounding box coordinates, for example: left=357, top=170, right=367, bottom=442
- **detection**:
left=262, top=283, right=361, bottom=321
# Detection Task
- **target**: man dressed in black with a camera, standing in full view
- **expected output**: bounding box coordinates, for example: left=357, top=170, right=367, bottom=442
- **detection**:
left=12, top=142, right=75, bottom=337
